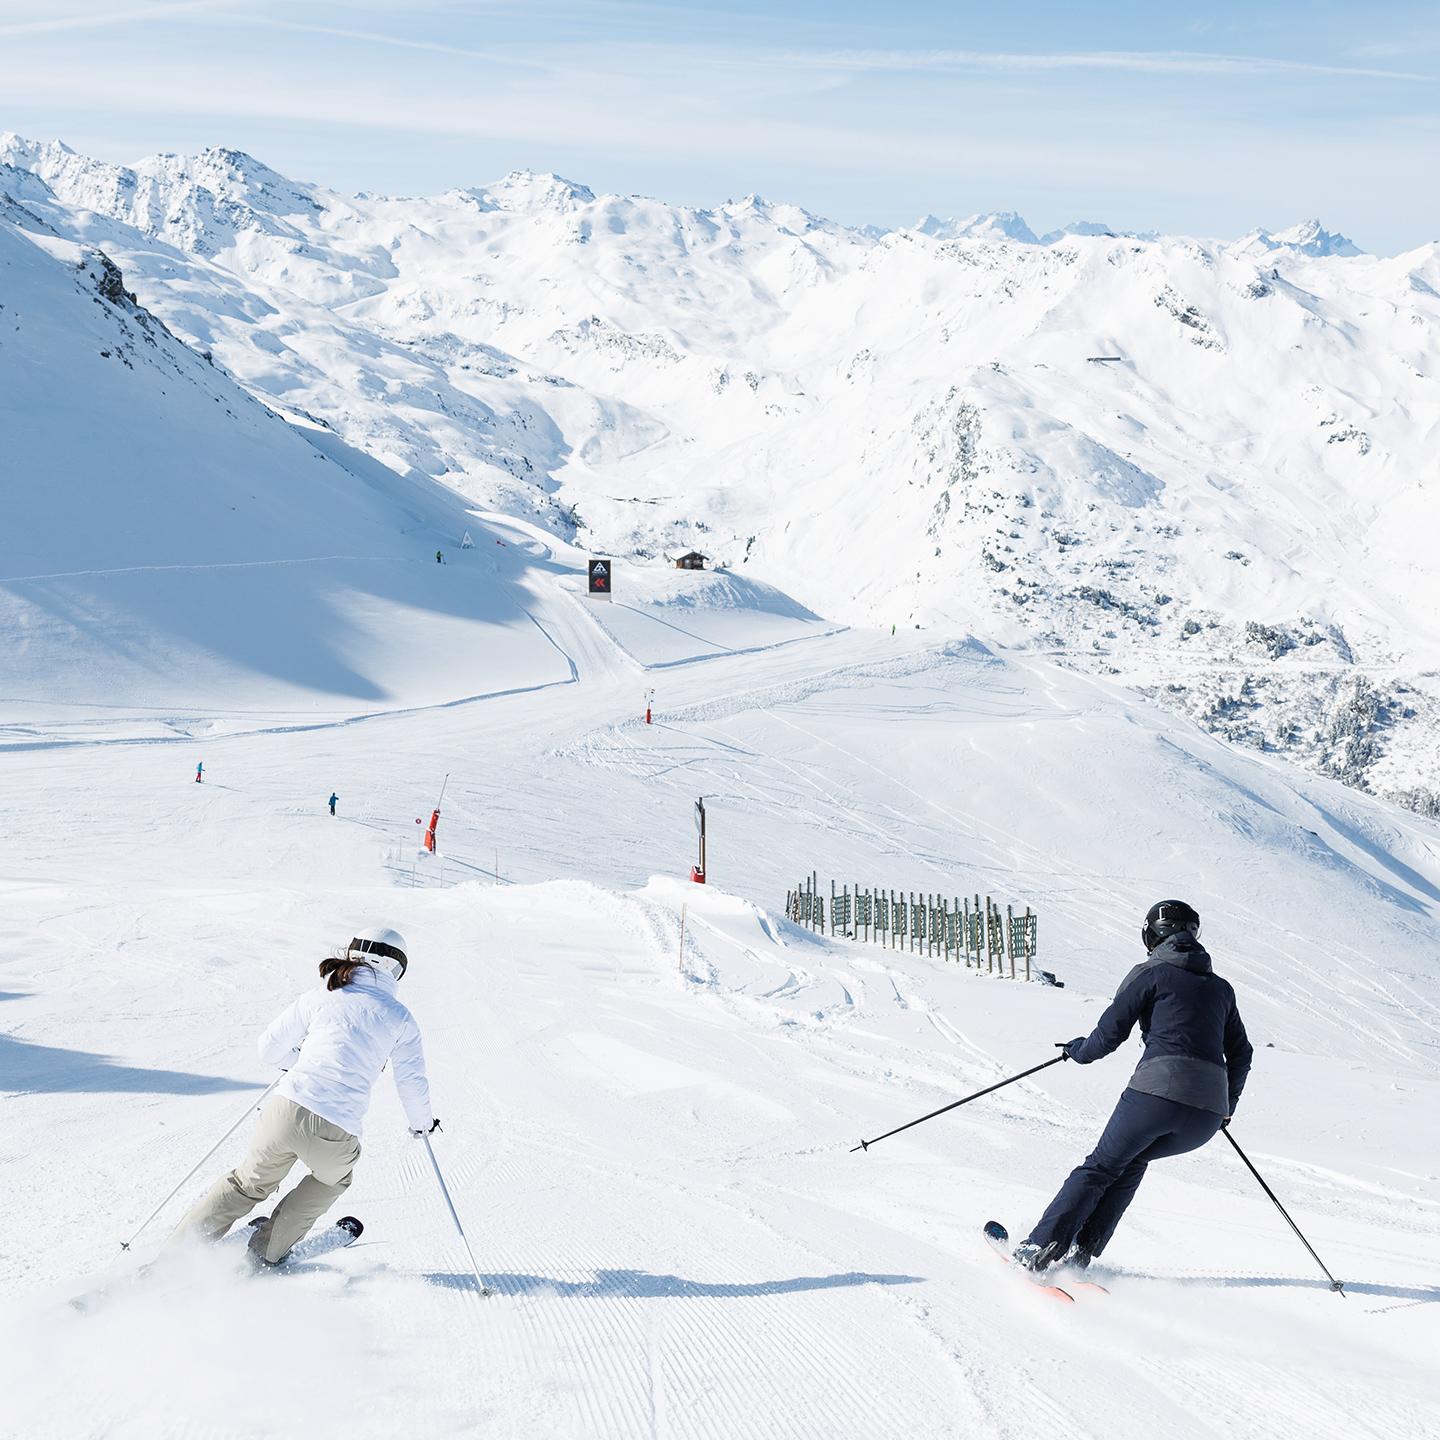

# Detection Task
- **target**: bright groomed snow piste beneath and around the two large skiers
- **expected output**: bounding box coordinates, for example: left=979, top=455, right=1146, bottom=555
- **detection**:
left=0, top=512, right=1440, bottom=1440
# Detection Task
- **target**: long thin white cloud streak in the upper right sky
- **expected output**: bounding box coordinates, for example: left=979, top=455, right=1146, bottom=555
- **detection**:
left=786, top=50, right=1434, bottom=81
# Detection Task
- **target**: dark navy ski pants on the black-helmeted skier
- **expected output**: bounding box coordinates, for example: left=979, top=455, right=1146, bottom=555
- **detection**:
left=1030, top=1090, right=1224, bottom=1263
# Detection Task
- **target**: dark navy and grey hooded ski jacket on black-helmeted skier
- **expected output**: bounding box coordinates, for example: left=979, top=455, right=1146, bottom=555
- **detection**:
left=1066, top=930, right=1254, bottom=1115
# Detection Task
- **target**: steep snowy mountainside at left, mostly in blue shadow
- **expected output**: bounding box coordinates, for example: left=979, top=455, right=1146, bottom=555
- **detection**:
left=0, top=181, right=566, bottom=723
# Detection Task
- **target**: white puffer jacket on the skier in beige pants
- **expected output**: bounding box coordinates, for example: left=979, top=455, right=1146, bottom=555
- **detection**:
left=258, top=965, right=432, bottom=1135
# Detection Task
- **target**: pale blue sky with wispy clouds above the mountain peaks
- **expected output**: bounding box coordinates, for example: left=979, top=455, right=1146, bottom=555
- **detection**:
left=0, top=0, right=1440, bottom=253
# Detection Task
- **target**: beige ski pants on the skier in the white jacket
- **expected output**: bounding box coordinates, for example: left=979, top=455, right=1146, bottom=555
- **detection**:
left=171, top=1094, right=360, bottom=1264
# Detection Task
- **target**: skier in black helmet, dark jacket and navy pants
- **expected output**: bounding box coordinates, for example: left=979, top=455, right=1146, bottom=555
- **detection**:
left=1015, top=900, right=1253, bottom=1270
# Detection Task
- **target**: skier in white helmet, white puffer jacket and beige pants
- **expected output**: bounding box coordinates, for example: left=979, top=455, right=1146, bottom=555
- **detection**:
left=173, top=927, right=439, bottom=1264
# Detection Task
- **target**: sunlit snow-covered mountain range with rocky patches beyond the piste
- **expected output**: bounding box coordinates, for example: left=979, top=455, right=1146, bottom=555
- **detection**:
left=0, top=137, right=1440, bottom=806
